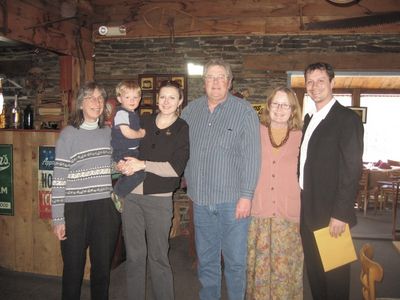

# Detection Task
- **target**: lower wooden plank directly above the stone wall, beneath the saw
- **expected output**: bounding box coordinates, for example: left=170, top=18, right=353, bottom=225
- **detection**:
left=93, top=16, right=400, bottom=41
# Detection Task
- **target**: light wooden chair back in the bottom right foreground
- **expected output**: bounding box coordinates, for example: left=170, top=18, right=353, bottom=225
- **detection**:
left=360, top=244, right=383, bottom=300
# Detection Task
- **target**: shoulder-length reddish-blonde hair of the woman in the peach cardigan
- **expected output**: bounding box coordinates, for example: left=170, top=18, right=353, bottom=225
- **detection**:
left=261, top=86, right=303, bottom=130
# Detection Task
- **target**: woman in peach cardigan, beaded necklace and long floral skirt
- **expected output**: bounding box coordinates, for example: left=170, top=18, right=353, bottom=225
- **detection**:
left=246, top=87, right=303, bottom=300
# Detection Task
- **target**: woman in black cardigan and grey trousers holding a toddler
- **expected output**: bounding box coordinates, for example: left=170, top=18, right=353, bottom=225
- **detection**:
left=118, top=81, right=189, bottom=300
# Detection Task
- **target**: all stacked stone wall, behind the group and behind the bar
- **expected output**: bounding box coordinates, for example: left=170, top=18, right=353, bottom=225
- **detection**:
left=0, top=34, right=400, bottom=108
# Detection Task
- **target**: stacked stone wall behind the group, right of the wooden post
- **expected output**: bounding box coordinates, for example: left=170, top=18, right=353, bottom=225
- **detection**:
left=95, top=35, right=400, bottom=103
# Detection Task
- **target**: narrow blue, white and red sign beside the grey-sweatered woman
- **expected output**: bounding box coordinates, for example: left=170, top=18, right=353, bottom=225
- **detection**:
left=38, top=146, right=56, bottom=219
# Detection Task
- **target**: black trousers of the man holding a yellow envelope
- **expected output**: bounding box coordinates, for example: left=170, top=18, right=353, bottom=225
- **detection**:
left=300, top=222, right=350, bottom=300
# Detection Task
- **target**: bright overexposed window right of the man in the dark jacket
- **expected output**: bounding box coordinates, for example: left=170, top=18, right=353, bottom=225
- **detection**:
left=360, top=94, right=400, bottom=162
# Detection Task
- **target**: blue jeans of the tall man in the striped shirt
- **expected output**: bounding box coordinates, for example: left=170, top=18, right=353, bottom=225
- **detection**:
left=193, top=203, right=249, bottom=300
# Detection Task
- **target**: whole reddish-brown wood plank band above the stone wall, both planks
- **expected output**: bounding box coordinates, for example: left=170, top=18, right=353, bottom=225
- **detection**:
left=92, top=0, right=400, bottom=40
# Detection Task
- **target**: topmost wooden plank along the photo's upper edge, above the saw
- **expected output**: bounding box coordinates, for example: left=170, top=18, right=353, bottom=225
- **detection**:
left=92, top=0, right=399, bottom=20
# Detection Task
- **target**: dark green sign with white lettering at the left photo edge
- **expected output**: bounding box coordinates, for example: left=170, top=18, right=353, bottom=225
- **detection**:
left=0, top=145, right=14, bottom=216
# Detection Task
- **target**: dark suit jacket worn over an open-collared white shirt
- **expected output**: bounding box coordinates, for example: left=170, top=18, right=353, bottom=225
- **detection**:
left=301, top=102, right=364, bottom=231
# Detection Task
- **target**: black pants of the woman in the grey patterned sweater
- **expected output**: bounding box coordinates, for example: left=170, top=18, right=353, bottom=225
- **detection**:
left=61, top=198, right=121, bottom=300
